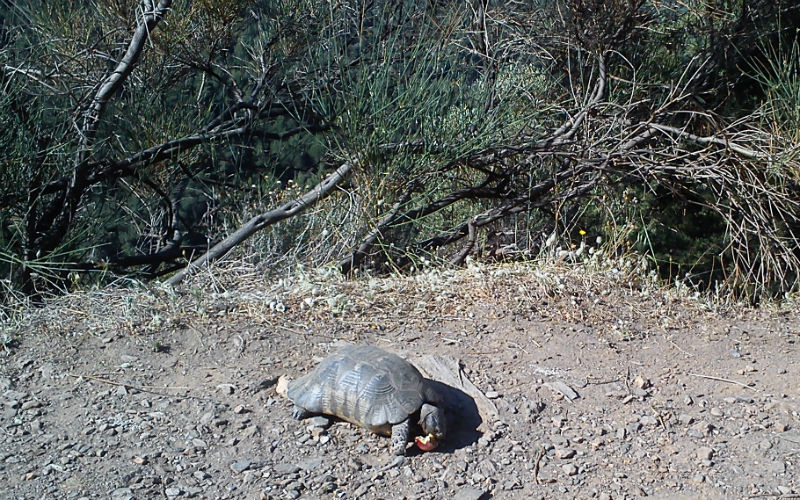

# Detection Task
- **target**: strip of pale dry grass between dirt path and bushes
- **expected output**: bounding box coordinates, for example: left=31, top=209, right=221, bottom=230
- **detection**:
left=3, top=249, right=780, bottom=352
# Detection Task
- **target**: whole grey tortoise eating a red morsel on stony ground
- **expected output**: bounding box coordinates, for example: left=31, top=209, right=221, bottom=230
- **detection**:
left=287, top=345, right=446, bottom=455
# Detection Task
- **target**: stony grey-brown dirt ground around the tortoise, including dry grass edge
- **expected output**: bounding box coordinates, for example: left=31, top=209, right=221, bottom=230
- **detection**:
left=0, top=265, right=800, bottom=500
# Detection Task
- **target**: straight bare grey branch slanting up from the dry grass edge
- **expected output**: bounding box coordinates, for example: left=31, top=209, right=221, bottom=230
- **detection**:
left=166, top=160, right=354, bottom=286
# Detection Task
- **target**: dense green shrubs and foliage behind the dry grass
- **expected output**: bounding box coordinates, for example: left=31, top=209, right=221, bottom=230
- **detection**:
left=0, top=0, right=800, bottom=300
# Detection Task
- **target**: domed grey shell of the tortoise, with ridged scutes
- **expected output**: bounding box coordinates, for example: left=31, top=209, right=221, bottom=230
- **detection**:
left=288, top=345, right=428, bottom=433
